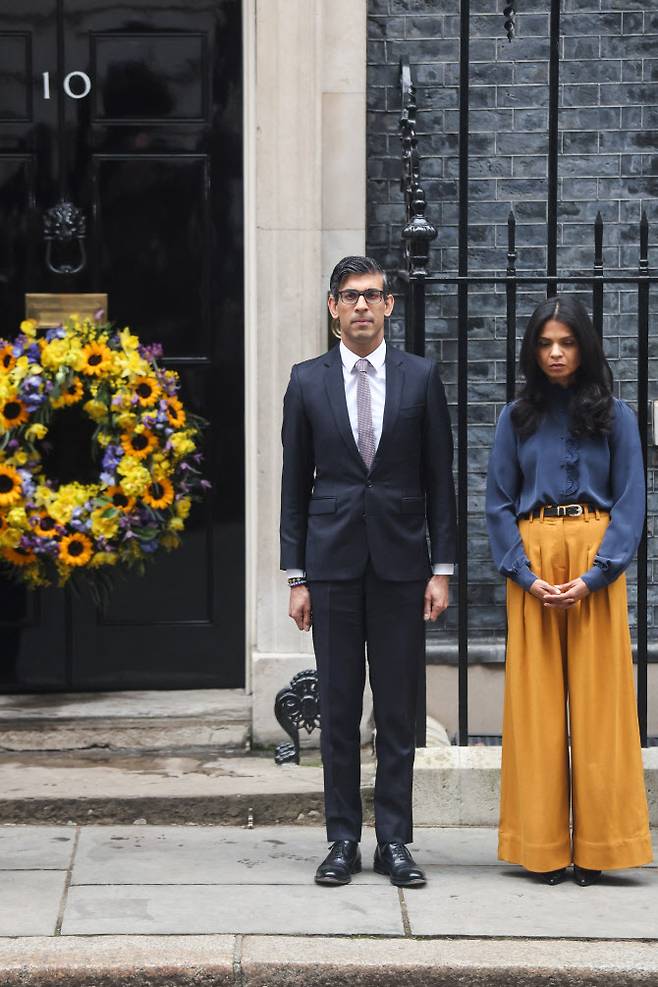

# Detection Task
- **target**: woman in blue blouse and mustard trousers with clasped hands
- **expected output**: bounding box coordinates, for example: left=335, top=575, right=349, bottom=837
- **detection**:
left=486, top=296, right=652, bottom=886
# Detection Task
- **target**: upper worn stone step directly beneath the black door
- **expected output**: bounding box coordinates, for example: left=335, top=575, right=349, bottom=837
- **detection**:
left=0, top=689, right=251, bottom=751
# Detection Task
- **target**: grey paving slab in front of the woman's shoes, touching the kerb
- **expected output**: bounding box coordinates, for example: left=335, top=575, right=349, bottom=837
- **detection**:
left=405, top=864, right=658, bottom=939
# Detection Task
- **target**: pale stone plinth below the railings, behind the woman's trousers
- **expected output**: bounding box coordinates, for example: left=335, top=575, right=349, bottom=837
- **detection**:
left=414, top=746, right=658, bottom=828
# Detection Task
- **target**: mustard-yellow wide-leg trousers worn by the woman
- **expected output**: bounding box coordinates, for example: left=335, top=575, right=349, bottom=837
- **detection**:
left=498, top=513, right=652, bottom=871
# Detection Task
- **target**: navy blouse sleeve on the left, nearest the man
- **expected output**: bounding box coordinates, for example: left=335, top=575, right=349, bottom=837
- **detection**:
left=486, top=404, right=537, bottom=590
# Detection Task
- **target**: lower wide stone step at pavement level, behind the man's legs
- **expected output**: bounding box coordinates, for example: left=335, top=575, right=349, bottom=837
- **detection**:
left=0, top=750, right=374, bottom=825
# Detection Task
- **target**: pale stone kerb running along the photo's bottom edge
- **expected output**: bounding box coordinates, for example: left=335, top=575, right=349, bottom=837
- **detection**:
left=0, top=935, right=658, bottom=987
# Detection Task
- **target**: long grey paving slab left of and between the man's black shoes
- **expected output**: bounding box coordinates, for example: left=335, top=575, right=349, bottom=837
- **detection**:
left=71, top=826, right=382, bottom=885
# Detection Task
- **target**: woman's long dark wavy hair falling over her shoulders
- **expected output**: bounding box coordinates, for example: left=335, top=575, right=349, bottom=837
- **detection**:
left=512, top=295, right=613, bottom=438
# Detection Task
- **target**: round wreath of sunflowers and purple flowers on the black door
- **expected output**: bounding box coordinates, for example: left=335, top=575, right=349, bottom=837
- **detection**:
left=0, top=316, right=210, bottom=589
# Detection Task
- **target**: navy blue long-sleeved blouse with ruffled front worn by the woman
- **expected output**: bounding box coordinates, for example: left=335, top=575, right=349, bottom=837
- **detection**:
left=486, top=384, right=645, bottom=592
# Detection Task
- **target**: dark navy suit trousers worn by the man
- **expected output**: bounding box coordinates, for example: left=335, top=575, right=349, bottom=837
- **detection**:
left=309, top=563, right=427, bottom=844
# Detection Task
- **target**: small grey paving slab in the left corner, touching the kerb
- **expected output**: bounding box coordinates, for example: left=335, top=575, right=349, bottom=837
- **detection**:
left=0, top=870, right=66, bottom=936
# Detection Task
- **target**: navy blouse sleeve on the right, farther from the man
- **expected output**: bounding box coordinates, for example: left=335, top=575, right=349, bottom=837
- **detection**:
left=582, top=401, right=646, bottom=592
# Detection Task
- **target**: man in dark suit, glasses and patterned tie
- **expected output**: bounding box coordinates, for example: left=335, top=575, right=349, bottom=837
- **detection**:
left=281, top=257, right=455, bottom=887
